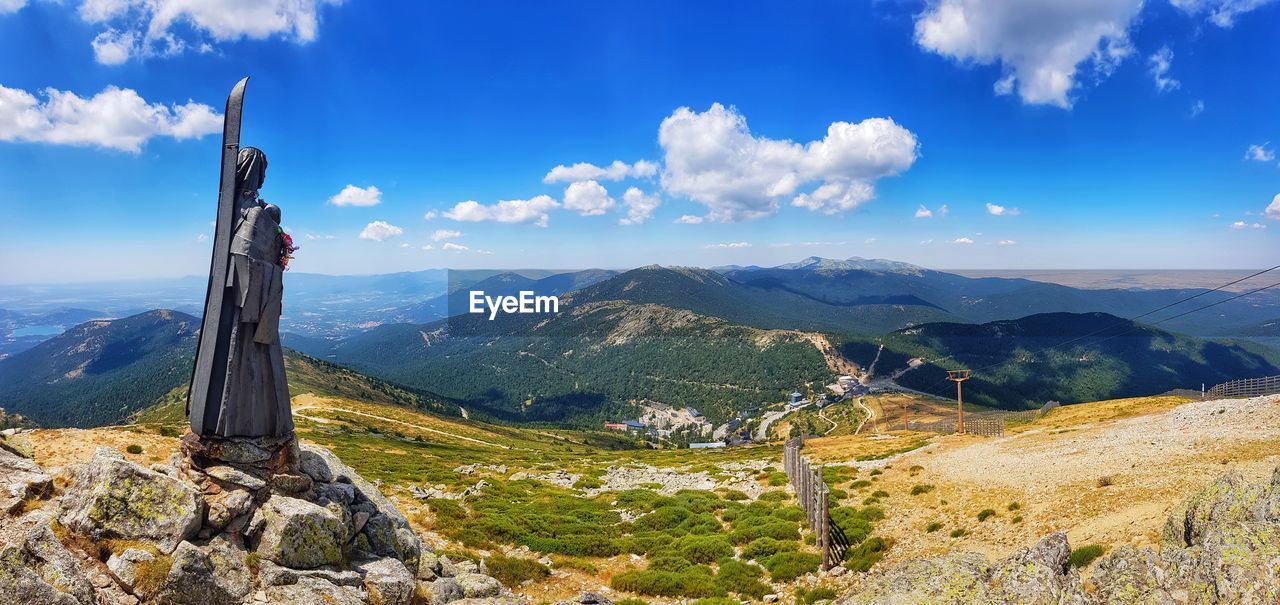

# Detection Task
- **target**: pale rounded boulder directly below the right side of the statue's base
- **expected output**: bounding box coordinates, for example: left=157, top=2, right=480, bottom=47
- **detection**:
left=251, top=495, right=346, bottom=569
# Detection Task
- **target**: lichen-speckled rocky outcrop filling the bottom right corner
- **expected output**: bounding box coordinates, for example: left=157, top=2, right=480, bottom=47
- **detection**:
left=837, top=468, right=1280, bottom=605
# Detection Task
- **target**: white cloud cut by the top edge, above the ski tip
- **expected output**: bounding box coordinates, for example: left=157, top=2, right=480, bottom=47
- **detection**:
left=76, top=0, right=342, bottom=65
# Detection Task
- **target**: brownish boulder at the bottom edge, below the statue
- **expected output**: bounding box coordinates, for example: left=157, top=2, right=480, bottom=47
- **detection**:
left=156, top=538, right=253, bottom=605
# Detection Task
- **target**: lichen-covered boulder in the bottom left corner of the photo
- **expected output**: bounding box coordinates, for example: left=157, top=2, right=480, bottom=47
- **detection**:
left=0, top=513, right=93, bottom=605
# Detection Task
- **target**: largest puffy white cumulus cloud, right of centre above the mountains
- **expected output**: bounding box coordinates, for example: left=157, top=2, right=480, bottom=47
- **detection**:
left=658, top=104, right=918, bottom=223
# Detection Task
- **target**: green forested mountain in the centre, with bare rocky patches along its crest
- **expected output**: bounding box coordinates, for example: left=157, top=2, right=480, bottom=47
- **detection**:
left=322, top=302, right=829, bottom=425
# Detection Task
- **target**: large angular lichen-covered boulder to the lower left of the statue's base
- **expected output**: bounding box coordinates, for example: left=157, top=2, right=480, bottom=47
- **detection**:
left=59, top=449, right=204, bottom=553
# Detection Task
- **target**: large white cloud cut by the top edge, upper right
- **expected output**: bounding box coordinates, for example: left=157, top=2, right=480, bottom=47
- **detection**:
left=915, top=0, right=1142, bottom=107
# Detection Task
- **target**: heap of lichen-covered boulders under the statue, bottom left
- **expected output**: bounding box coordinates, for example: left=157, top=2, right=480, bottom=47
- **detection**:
left=0, top=437, right=520, bottom=605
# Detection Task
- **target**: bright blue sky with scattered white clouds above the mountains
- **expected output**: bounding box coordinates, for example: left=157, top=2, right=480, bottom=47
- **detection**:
left=0, top=0, right=1280, bottom=283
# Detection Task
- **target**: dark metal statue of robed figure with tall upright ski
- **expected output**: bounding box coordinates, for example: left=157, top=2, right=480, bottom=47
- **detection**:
left=187, top=78, right=293, bottom=437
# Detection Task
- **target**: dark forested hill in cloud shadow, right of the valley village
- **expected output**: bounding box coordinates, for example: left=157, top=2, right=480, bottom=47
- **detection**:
left=845, top=313, right=1280, bottom=409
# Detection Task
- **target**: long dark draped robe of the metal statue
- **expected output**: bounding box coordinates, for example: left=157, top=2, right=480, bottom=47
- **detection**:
left=192, top=198, right=293, bottom=437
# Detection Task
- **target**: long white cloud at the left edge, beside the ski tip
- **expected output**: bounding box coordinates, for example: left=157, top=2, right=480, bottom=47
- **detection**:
left=0, top=81, right=223, bottom=153
